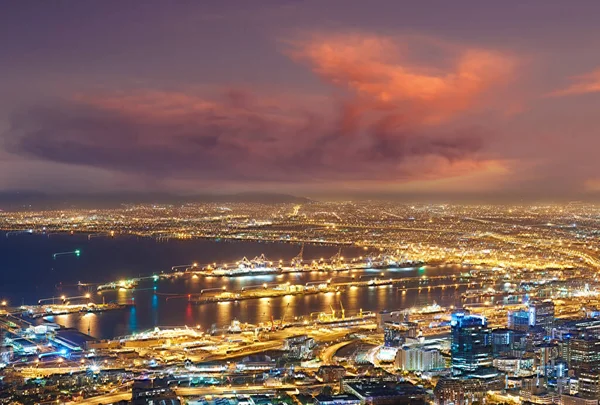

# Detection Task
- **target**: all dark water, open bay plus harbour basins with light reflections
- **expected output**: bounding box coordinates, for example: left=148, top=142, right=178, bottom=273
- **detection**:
left=0, top=235, right=474, bottom=338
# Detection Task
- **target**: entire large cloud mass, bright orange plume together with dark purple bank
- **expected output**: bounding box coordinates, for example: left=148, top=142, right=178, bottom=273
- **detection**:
left=9, top=34, right=517, bottom=192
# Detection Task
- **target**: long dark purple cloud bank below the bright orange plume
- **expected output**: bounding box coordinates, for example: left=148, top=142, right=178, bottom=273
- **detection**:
left=5, top=90, right=482, bottom=182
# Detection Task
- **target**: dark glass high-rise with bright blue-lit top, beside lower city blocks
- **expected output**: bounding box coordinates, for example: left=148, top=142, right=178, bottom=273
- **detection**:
left=450, top=312, right=493, bottom=374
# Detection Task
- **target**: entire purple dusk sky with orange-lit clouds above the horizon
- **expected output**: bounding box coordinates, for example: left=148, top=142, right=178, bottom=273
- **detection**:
left=0, top=0, right=600, bottom=199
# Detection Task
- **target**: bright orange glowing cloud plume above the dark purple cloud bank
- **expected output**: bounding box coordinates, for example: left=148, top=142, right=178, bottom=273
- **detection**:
left=290, top=34, right=516, bottom=123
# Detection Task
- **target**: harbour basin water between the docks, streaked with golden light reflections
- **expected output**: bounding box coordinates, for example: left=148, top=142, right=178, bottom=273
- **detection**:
left=36, top=267, right=466, bottom=338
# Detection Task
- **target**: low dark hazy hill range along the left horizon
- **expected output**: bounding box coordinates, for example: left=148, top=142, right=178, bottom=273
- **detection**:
left=0, top=191, right=311, bottom=211
